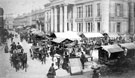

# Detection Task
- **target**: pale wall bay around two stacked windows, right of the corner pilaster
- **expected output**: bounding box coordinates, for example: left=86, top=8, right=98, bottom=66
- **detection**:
left=109, top=0, right=129, bottom=34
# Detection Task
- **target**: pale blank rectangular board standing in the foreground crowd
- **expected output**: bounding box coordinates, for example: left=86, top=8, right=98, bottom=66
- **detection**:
left=69, top=58, right=82, bottom=74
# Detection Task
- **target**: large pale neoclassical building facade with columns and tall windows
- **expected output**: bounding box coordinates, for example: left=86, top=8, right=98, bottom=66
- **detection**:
left=45, top=0, right=135, bottom=34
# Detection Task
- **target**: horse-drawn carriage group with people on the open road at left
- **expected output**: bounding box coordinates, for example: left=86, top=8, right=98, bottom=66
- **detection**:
left=4, top=33, right=27, bottom=71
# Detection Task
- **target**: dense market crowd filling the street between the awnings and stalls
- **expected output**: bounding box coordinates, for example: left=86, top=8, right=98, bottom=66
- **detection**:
left=5, top=29, right=134, bottom=78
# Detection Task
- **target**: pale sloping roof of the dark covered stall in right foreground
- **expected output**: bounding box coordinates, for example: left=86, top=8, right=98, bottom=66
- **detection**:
left=102, top=44, right=124, bottom=53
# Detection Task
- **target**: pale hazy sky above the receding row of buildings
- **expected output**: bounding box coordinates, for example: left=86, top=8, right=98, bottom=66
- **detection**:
left=0, top=0, right=49, bottom=17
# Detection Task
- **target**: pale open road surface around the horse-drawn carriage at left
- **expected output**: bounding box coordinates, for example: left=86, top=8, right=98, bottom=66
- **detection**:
left=0, top=31, right=69, bottom=78
